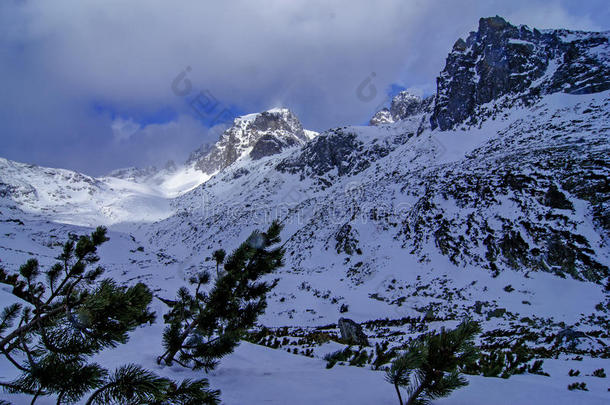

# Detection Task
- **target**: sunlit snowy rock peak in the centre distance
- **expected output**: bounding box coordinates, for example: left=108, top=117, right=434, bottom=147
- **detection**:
left=189, top=108, right=316, bottom=175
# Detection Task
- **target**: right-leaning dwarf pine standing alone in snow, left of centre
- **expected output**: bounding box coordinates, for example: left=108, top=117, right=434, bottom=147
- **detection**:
left=158, top=222, right=284, bottom=371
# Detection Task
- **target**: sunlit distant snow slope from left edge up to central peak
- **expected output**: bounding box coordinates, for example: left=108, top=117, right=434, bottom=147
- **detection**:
left=0, top=108, right=317, bottom=226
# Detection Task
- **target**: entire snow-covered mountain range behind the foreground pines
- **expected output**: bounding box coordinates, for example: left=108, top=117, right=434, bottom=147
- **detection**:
left=0, top=17, right=610, bottom=404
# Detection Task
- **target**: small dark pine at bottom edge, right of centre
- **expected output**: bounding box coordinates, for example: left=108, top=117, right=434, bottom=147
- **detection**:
left=386, top=320, right=480, bottom=405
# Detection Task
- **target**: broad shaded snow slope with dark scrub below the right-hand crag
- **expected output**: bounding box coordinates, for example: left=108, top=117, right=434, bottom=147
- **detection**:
left=146, top=88, right=610, bottom=325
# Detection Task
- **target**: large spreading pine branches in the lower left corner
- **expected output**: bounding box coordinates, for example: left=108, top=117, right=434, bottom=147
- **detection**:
left=0, top=227, right=217, bottom=404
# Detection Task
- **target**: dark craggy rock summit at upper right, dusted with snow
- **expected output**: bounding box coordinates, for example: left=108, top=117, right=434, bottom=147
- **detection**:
left=431, top=16, right=610, bottom=130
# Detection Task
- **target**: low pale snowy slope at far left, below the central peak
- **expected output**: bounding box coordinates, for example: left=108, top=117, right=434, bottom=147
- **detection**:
left=0, top=158, right=172, bottom=226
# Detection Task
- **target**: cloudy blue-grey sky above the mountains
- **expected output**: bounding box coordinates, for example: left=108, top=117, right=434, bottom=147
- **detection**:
left=0, top=0, right=610, bottom=175
